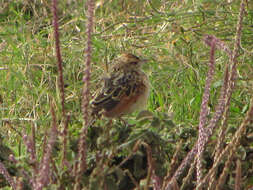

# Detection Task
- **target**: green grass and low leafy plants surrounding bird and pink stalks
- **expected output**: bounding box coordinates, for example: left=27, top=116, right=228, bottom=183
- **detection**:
left=0, top=0, right=253, bottom=190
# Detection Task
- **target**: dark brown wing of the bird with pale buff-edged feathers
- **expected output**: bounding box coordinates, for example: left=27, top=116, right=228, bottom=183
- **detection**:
left=91, top=72, right=139, bottom=114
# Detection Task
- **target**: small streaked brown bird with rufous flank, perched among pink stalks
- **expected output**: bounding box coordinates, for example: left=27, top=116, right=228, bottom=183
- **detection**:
left=91, top=53, right=150, bottom=118
